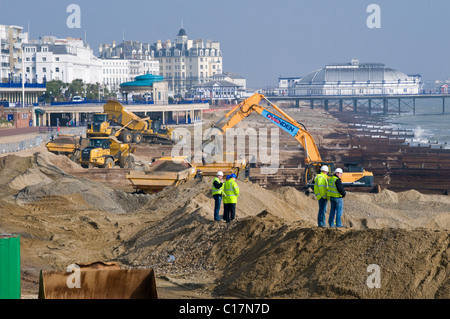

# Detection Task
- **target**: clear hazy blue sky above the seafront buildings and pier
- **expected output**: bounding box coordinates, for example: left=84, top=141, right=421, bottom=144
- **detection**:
left=0, top=0, right=450, bottom=89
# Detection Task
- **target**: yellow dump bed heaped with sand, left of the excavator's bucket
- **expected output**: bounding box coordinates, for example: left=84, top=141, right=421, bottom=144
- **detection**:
left=127, top=156, right=196, bottom=194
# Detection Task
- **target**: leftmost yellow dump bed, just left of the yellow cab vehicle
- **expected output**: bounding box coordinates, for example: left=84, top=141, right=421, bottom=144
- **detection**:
left=45, top=135, right=89, bottom=163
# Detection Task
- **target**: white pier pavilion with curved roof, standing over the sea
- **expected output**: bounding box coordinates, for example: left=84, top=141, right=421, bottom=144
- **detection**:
left=294, top=59, right=422, bottom=95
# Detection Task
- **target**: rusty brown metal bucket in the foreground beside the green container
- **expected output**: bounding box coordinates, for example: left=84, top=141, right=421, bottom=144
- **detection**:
left=38, top=262, right=158, bottom=299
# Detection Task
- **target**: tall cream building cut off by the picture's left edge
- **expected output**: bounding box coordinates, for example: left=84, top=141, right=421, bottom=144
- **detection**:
left=0, top=25, right=28, bottom=83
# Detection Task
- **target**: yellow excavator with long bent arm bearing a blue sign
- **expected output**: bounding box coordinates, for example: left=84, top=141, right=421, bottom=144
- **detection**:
left=202, top=93, right=374, bottom=187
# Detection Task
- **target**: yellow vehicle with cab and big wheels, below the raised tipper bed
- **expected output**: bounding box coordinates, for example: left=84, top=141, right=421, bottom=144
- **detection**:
left=80, top=137, right=136, bottom=168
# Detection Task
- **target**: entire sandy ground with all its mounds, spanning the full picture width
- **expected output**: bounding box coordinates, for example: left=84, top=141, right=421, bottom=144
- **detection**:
left=0, top=149, right=450, bottom=298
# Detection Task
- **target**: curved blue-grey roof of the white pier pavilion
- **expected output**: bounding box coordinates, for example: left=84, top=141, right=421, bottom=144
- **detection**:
left=299, top=59, right=410, bottom=85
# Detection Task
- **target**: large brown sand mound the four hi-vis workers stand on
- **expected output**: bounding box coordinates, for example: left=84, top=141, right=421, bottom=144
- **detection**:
left=116, top=180, right=450, bottom=298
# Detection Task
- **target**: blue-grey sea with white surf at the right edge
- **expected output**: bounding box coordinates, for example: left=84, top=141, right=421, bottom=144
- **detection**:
left=383, top=98, right=450, bottom=149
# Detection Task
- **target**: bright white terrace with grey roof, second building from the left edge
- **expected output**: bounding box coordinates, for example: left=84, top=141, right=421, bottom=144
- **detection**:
left=24, top=36, right=103, bottom=84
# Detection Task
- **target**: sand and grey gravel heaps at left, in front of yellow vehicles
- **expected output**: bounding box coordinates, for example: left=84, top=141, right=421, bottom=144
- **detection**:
left=0, top=152, right=152, bottom=213
